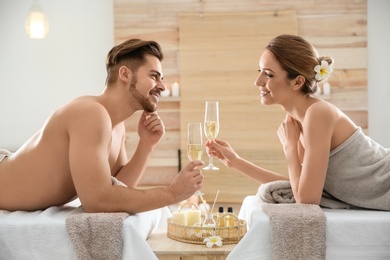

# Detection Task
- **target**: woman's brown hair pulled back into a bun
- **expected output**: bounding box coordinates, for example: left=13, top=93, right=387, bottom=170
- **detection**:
left=266, top=34, right=334, bottom=95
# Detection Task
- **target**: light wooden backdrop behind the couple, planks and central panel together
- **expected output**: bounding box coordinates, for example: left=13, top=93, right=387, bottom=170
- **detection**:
left=114, top=0, right=368, bottom=202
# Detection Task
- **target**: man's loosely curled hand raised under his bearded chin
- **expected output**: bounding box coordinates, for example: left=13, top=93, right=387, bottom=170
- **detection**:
left=138, top=111, right=165, bottom=147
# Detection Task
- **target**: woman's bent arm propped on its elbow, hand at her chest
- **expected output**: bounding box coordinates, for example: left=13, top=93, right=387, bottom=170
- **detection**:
left=284, top=102, right=336, bottom=204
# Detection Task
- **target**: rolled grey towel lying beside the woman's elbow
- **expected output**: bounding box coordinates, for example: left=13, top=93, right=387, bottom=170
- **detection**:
left=256, top=181, right=295, bottom=203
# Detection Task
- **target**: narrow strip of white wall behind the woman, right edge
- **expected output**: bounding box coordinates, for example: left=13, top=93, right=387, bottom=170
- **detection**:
left=367, top=0, right=390, bottom=148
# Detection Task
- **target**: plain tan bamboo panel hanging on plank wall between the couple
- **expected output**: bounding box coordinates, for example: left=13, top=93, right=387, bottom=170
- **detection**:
left=179, top=11, right=297, bottom=203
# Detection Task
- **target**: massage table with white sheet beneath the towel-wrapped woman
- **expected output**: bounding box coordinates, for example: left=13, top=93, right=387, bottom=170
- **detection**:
left=227, top=196, right=390, bottom=260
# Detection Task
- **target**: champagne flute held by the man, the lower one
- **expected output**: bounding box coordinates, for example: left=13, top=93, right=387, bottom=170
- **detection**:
left=187, top=123, right=204, bottom=203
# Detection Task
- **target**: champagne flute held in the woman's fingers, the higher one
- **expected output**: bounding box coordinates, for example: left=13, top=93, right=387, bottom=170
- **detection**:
left=203, top=101, right=219, bottom=171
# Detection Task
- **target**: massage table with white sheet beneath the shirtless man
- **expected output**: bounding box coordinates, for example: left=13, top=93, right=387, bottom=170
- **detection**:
left=0, top=200, right=171, bottom=260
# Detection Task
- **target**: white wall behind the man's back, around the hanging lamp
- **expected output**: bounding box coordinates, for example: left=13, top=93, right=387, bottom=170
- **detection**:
left=0, top=0, right=114, bottom=150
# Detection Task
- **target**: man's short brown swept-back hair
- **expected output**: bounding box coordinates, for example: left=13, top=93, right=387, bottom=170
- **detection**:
left=106, top=39, right=164, bottom=85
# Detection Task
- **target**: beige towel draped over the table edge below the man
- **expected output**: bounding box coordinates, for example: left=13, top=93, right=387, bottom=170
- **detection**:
left=66, top=177, right=129, bottom=260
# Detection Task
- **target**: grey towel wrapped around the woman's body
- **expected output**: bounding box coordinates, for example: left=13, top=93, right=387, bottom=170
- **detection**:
left=324, top=127, right=390, bottom=211
